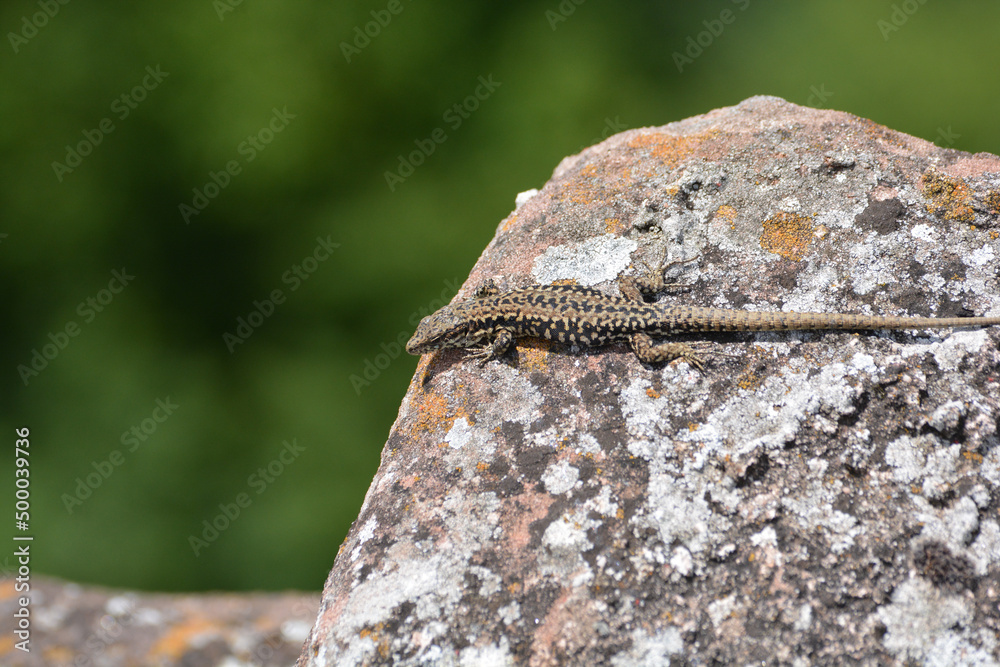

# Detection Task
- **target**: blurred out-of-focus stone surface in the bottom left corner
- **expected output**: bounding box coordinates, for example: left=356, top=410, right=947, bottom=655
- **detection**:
left=0, top=576, right=319, bottom=667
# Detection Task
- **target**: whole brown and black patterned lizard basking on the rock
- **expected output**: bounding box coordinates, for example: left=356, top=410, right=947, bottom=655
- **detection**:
left=406, top=260, right=1000, bottom=372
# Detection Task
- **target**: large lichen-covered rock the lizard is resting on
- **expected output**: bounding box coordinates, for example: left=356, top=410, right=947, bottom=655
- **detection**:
left=299, top=97, right=1000, bottom=667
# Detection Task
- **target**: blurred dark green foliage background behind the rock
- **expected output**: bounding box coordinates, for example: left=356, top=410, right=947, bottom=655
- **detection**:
left=0, top=0, right=1000, bottom=590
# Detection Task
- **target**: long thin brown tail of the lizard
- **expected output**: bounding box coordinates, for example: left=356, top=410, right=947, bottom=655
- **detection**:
left=670, top=306, right=1000, bottom=331
